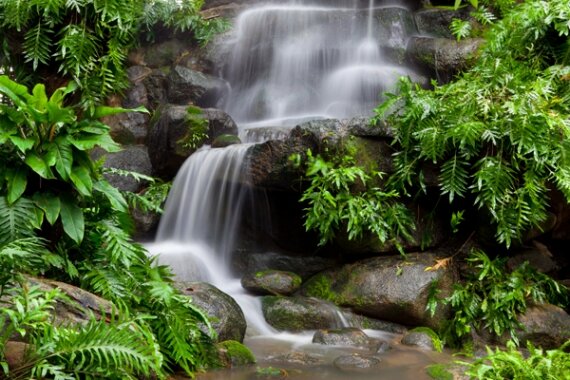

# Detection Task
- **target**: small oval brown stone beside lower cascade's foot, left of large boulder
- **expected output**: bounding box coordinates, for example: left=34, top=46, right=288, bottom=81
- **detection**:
left=241, top=270, right=303, bottom=296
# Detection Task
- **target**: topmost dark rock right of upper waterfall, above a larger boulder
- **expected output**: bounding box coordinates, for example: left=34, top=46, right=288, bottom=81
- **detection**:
left=414, top=7, right=472, bottom=38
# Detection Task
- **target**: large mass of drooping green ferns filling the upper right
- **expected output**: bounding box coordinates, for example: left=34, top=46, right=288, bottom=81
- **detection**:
left=376, top=0, right=570, bottom=247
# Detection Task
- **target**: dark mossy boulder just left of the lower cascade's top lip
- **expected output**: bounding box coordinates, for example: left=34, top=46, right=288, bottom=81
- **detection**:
left=147, top=105, right=237, bottom=180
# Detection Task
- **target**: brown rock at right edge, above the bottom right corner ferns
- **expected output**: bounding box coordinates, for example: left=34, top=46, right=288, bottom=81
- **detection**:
left=510, top=304, right=570, bottom=349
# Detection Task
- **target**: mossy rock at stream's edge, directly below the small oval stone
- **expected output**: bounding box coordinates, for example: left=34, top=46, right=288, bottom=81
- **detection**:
left=261, top=296, right=342, bottom=332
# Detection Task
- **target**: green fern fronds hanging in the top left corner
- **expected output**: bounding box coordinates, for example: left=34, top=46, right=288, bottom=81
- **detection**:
left=0, top=0, right=224, bottom=109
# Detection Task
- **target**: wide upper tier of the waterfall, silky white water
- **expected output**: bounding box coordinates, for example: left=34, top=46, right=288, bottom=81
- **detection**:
left=223, top=1, right=416, bottom=125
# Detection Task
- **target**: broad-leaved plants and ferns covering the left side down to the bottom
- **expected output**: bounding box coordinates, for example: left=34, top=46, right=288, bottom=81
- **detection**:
left=0, top=76, right=210, bottom=379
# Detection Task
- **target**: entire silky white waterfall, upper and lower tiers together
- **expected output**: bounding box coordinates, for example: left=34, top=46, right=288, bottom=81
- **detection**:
left=149, top=0, right=430, bottom=372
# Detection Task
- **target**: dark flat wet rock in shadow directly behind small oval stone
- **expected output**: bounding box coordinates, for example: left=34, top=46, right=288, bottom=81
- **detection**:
left=237, top=252, right=337, bottom=279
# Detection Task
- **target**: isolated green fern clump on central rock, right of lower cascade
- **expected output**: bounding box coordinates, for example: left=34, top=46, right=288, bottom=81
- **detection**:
left=293, top=150, right=414, bottom=247
